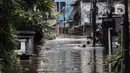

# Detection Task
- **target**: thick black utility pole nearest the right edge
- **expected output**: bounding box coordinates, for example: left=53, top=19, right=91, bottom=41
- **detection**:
left=123, top=0, right=130, bottom=73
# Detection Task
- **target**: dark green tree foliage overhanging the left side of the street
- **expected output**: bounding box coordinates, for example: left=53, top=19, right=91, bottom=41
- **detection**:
left=0, top=0, right=54, bottom=69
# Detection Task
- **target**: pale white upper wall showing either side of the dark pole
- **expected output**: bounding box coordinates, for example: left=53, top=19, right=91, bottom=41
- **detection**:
left=81, top=2, right=106, bottom=25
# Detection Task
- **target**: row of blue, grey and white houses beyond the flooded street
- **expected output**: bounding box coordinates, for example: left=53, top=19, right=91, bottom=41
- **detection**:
left=55, top=0, right=121, bottom=35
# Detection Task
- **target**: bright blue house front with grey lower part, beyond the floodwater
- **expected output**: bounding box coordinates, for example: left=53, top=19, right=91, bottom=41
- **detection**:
left=55, top=0, right=72, bottom=34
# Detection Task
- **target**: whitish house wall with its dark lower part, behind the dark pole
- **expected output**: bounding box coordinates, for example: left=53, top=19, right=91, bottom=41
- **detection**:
left=80, top=1, right=106, bottom=35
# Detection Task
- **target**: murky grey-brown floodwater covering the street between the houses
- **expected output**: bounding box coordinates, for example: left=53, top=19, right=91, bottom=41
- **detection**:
left=13, top=38, right=104, bottom=73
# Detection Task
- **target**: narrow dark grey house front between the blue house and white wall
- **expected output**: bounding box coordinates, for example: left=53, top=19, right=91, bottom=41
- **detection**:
left=68, top=0, right=82, bottom=35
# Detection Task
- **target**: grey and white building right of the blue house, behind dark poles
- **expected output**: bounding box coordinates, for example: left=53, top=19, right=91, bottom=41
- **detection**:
left=69, top=0, right=121, bottom=35
